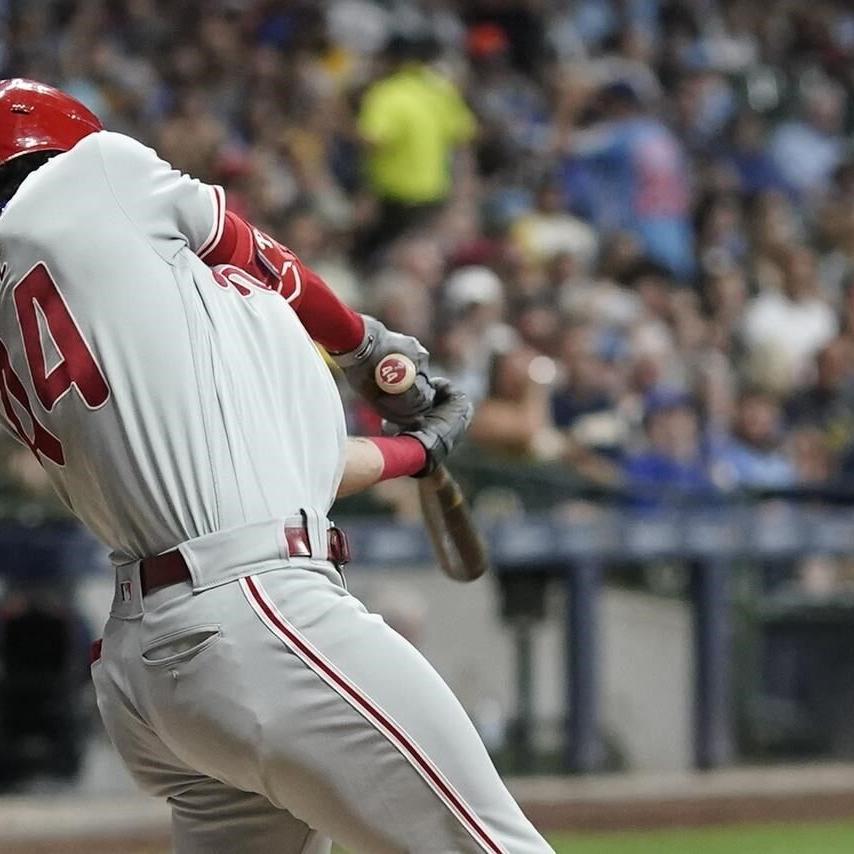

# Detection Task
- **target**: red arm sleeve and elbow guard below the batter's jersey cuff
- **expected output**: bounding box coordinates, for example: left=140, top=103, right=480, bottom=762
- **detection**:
left=198, top=211, right=365, bottom=353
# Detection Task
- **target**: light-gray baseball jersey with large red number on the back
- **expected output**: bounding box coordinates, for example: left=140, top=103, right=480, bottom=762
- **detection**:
left=0, top=132, right=344, bottom=558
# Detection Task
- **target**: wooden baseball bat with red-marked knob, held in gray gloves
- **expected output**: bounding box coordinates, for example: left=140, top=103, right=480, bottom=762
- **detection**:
left=374, top=353, right=489, bottom=581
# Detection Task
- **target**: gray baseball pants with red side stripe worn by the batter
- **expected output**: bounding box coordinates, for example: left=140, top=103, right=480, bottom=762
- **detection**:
left=92, top=522, right=552, bottom=854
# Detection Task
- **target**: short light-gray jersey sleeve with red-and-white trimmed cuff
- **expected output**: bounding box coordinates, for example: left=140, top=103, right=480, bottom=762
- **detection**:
left=98, top=131, right=225, bottom=261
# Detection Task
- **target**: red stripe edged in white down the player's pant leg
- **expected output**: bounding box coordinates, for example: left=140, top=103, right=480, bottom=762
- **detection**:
left=240, top=576, right=507, bottom=854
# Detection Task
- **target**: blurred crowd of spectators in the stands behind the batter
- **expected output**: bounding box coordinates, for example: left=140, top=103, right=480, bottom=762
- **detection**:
left=5, top=0, right=854, bottom=504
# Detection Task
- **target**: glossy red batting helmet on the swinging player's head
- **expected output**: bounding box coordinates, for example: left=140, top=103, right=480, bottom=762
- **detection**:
left=0, top=78, right=103, bottom=166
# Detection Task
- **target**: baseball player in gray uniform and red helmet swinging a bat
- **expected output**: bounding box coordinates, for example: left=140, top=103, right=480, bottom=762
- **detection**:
left=0, top=80, right=551, bottom=854
